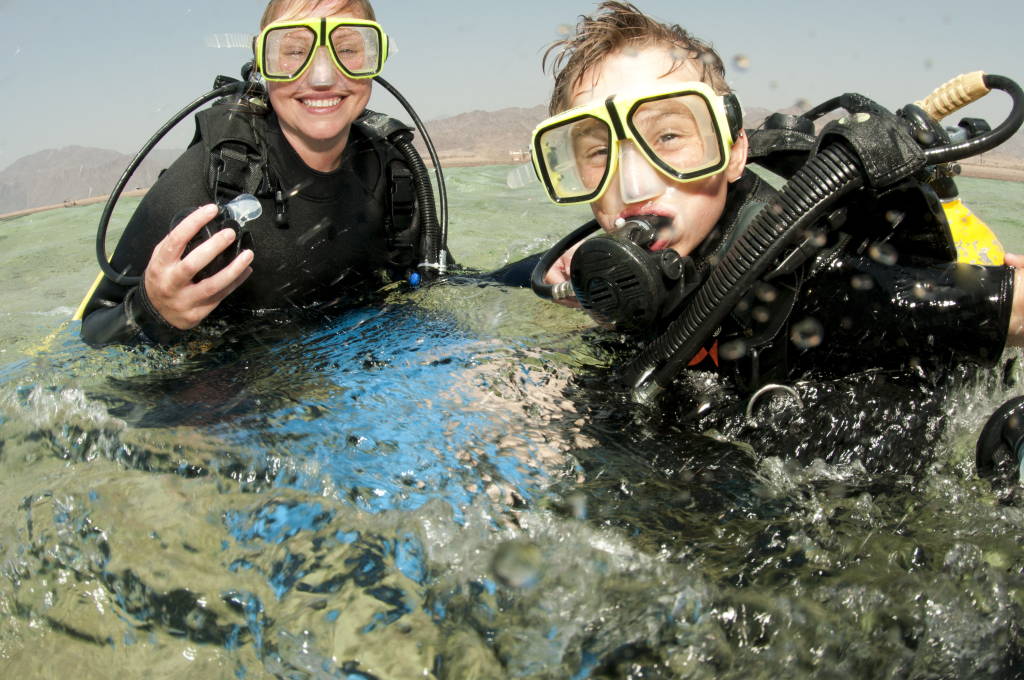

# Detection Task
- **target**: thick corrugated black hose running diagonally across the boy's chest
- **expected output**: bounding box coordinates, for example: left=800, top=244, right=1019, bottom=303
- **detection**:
left=624, top=142, right=865, bottom=402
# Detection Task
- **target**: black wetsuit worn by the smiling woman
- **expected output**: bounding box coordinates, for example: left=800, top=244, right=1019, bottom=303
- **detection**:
left=82, top=105, right=415, bottom=346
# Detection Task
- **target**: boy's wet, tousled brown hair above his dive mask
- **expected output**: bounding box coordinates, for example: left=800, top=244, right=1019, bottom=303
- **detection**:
left=544, top=1, right=730, bottom=116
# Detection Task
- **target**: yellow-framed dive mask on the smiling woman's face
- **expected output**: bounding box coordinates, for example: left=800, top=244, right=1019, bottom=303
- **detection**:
left=256, top=16, right=388, bottom=82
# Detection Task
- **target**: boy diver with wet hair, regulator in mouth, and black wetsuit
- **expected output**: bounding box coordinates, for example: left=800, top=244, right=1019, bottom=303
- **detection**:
left=532, top=2, right=1024, bottom=389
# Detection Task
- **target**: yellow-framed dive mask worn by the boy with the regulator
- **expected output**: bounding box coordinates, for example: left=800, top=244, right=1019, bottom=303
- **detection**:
left=530, top=82, right=742, bottom=204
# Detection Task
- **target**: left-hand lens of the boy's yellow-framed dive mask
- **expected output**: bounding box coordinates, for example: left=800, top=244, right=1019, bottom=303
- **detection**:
left=534, top=116, right=611, bottom=203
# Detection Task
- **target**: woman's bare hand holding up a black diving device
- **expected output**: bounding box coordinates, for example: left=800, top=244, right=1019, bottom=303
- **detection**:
left=141, top=204, right=253, bottom=331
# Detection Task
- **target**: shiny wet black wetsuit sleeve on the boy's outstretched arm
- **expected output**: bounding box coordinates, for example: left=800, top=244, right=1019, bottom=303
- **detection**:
left=791, top=256, right=1014, bottom=370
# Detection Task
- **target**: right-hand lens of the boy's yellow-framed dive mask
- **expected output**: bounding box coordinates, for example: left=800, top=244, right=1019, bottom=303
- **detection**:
left=627, top=92, right=728, bottom=180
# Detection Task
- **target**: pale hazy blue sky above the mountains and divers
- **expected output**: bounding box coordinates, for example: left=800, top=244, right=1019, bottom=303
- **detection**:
left=0, top=0, right=1024, bottom=169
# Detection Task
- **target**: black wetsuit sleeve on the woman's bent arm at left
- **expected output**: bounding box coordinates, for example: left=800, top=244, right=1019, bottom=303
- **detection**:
left=81, top=144, right=211, bottom=347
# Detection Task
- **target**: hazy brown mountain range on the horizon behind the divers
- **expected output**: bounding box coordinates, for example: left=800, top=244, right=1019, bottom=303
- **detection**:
left=0, top=105, right=1024, bottom=214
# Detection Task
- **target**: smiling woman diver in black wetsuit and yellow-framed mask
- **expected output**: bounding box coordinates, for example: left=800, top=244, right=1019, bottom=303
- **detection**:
left=81, top=0, right=443, bottom=346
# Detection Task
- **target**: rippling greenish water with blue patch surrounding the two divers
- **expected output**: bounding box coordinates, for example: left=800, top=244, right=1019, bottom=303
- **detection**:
left=0, top=167, right=1024, bottom=679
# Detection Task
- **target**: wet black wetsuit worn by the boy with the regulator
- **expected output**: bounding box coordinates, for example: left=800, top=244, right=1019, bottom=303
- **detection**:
left=691, top=172, right=1014, bottom=388
